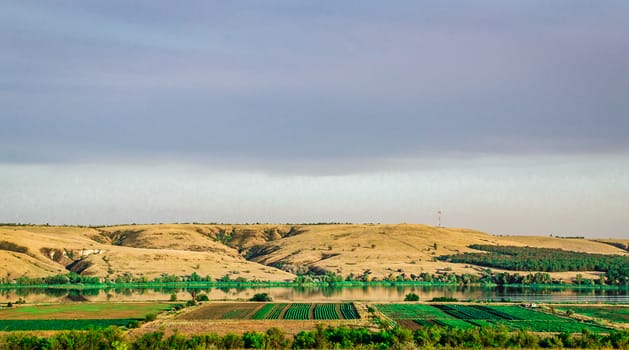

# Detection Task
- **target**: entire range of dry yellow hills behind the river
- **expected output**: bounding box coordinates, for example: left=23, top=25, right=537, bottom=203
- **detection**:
left=0, top=224, right=629, bottom=281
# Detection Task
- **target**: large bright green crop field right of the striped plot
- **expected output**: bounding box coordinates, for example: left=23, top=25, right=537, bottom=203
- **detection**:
left=377, top=304, right=610, bottom=333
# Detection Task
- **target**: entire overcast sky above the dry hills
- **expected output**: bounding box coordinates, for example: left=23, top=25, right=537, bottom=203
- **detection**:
left=0, top=0, right=629, bottom=238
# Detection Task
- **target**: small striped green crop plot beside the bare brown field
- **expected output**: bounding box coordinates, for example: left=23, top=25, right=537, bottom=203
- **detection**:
left=251, top=303, right=359, bottom=320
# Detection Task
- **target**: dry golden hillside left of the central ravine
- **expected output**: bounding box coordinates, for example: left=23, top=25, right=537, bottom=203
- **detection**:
left=0, top=225, right=295, bottom=281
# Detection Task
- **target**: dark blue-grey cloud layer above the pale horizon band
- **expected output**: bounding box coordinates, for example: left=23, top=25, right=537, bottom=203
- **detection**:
left=0, top=1, right=629, bottom=170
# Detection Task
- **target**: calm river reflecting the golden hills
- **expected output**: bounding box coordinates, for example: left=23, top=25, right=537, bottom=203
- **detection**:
left=0, top=285, right=629, bottom=304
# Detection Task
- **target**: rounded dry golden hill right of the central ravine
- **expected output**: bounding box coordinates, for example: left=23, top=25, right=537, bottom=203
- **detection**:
left=243, top=224, right=627, bottom=278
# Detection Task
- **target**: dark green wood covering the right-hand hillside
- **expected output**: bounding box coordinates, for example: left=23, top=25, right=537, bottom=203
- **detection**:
left=439, top=244, right=629, bottom=286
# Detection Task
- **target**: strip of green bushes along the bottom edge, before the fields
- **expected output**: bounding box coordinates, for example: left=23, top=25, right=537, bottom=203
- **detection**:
left=0, top=325, right=629, bottom=350
